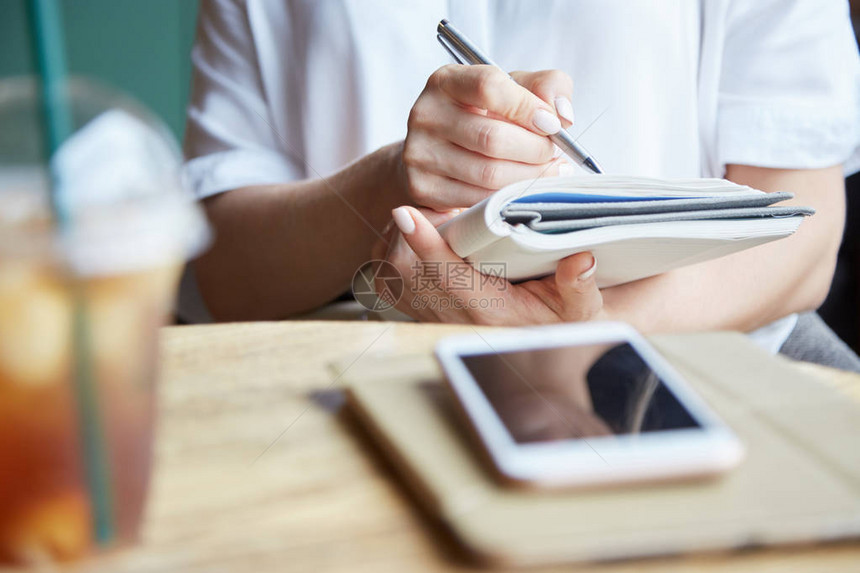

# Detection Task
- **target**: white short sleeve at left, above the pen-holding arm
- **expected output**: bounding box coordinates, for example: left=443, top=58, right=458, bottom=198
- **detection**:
left=184, top=0, right=303, bottom=198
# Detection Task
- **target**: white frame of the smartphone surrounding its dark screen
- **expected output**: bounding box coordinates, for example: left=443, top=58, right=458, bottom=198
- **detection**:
left=436, top=322, right=745, bottom=487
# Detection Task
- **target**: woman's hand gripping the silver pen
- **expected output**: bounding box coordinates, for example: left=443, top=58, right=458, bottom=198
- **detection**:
left=401, top=65, right=573, bottom=211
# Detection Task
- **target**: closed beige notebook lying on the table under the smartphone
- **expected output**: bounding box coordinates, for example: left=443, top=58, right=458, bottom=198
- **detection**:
left=345, top=333, right=860, bottom=565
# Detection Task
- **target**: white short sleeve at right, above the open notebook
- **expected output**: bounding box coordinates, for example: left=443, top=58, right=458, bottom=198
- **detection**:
left=717, top=0, right=860, bottom=172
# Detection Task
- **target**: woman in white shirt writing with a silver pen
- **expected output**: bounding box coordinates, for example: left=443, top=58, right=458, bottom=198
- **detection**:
left=181, top=0, right=860, bottom=367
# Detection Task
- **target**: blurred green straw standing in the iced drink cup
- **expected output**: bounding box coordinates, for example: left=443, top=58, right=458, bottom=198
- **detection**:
left=29, top=0, right=114, bottom=545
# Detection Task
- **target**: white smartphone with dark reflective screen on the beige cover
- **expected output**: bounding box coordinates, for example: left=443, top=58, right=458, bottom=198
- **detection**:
left=436, top=322, right=744, bottom=486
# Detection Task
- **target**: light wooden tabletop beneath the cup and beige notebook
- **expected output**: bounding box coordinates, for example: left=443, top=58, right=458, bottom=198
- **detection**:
left=63, top=321, right=860, bottom=573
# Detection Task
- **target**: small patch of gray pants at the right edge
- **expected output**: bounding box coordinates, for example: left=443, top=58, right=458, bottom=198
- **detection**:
left=779, top=312, right=860, bottom=373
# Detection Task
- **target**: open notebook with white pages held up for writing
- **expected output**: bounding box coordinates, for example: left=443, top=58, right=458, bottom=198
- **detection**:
left=439, top=175, right=815, bottom=288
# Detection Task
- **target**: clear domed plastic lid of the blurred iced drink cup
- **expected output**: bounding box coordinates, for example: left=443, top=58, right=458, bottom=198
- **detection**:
left=0, top=79, right=210, bottom=275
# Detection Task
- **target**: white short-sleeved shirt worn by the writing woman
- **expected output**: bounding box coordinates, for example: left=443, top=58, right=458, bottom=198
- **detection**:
left=185, top=0, right=860, bottom=350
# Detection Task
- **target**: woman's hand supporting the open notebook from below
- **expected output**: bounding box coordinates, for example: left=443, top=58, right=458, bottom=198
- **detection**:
left=374, top=207, right=608, bottom=326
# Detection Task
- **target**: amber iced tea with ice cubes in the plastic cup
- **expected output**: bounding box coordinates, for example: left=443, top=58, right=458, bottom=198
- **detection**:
left=0, top=255, right=178, bottom=563
